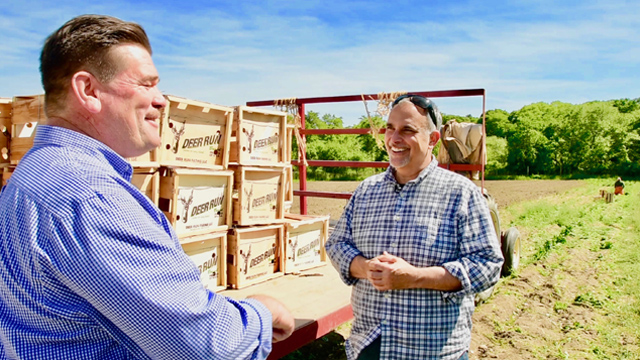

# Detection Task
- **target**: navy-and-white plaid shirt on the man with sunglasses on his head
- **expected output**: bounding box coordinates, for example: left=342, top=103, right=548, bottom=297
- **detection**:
left=326, top=158, right=503, bottom=360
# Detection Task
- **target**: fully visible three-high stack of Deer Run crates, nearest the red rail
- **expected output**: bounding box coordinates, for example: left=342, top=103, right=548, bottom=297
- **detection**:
left=227, top=106, right=287, bottom=289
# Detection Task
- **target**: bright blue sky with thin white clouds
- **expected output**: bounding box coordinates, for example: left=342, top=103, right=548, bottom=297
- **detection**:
left=0, top=0, right=640, bottom=125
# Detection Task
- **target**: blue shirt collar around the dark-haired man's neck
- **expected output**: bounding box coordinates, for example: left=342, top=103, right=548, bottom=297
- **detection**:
left=33, top=125, right=133, bottom=180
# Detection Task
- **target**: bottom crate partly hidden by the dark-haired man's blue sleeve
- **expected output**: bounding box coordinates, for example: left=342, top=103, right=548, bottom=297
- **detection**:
left=180, top=231, right=227, bottom=292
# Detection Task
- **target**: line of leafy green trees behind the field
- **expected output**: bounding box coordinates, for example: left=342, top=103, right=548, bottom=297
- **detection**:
left=292, top=98, right=640, bottom=180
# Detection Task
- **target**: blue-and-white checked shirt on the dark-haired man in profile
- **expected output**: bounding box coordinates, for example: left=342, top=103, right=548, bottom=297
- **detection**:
left=0, top=126, right=272, bottom=360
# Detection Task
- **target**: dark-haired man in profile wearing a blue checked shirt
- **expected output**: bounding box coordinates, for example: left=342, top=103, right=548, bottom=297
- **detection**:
left=0, top=15, right=294, bottom=360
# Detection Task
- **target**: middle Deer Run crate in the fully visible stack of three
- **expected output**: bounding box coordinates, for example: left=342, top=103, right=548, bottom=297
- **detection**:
left=229, top=165, right=285, bottom=226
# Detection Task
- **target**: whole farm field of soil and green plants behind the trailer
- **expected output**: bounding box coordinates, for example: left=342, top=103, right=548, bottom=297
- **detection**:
left=285, top=179, right=640, bottom=360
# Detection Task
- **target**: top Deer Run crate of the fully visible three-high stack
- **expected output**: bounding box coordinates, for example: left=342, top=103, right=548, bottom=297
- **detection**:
left=229, top=106, right=287, bottom=166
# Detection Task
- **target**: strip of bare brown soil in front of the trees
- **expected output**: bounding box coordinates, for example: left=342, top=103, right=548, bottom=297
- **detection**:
left=290, top=180, right=580, bottom=221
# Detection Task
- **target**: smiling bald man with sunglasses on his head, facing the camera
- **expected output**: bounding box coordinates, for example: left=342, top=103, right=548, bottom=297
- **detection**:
left=326, top=95, right=504, bottom=360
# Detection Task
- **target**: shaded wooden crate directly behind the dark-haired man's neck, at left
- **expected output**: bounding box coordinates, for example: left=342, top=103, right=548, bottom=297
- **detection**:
left=9, top=95, right=47, bottom=165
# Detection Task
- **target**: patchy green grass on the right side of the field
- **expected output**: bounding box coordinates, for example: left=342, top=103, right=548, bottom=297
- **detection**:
left=501, top=179, right=640, bottom=359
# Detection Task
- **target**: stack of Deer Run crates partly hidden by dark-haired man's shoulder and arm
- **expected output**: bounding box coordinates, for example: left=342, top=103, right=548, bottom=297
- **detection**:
left=147, top=96, right=234, bottom=291
